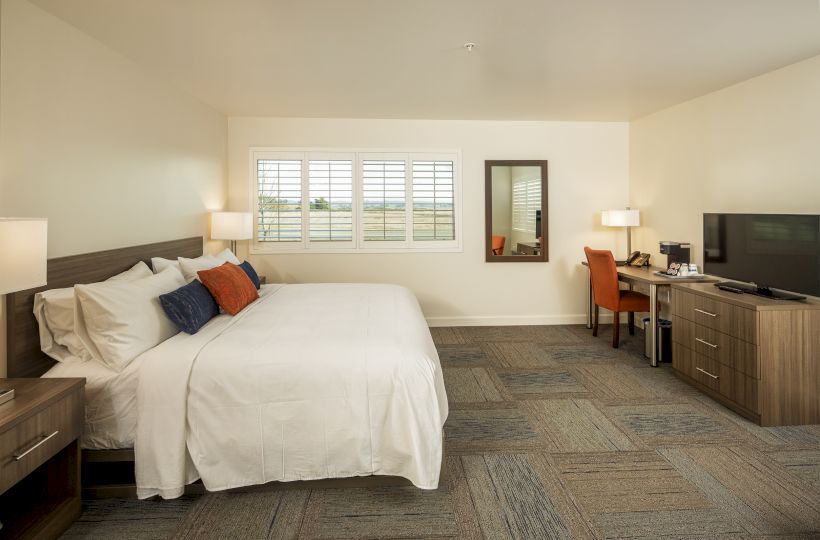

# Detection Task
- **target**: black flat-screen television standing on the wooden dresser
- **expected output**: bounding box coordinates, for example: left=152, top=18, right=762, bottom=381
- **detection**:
left=703, top=214, right=820, bottom=300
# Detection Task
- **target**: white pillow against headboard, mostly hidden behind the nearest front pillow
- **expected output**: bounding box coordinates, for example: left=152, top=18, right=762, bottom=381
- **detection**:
left=34, top=261, right=152, bottom=362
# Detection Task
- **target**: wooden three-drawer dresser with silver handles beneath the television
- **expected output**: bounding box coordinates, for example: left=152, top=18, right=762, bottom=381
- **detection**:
left=672, top=283, right=820, bottom=426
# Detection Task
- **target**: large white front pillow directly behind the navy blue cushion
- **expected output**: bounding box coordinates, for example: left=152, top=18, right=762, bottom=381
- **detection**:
left=74, top=268, right=185, bottom=371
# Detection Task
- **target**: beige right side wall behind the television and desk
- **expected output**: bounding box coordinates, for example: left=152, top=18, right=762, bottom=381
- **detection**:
left=630, top=56, right=820, bottom=265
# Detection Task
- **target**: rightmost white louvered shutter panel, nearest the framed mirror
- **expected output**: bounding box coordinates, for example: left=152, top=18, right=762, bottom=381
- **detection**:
left=413, top=161, right=455, bottom=241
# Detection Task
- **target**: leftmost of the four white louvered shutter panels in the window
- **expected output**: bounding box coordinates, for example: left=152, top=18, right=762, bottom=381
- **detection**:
left=256, top=159, right=302, bottom=242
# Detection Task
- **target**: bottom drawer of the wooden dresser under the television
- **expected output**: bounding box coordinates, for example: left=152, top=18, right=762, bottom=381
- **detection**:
left=672, top=343, right=760, bottom=414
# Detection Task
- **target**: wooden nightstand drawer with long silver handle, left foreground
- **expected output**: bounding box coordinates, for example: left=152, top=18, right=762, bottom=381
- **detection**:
left=0, top=389, right=83, bottom=493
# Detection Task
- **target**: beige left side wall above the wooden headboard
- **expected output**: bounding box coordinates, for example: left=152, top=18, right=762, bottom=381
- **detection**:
left=0, top=0, right=227, bottom=376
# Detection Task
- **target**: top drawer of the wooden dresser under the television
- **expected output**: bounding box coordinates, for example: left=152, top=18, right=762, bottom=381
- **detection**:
left=672, top=288, right=758, bottom=343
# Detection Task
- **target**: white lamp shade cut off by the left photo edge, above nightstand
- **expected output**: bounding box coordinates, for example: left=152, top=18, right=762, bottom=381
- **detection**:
left=0, top=218, right=48, bottom=294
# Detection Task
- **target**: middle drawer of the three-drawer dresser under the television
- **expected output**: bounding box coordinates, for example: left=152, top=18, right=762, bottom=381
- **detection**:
left=672, top=315, right=760, bottom=379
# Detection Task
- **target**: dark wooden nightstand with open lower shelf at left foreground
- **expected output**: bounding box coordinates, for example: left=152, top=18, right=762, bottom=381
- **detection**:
left=0, top=379, right=85, bottom=538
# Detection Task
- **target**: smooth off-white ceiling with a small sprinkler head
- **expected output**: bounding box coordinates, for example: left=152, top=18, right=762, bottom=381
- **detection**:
left=33, top=0, right=820, bottom=120
